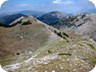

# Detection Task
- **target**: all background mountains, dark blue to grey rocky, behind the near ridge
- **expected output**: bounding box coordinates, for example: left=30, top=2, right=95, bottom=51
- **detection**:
left=0, top=11, right=96, bottom=40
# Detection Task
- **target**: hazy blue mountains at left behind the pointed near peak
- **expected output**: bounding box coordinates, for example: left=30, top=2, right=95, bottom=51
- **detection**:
left=0, top=10, right=45, bottom=25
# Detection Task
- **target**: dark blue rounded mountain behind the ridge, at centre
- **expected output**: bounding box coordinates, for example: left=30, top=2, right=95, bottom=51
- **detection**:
left=38, top=11, right=67, bottom=25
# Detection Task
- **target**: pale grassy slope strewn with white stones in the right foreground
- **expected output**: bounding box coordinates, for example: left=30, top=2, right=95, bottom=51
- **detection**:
left=4, top=30, right=96, bottom=72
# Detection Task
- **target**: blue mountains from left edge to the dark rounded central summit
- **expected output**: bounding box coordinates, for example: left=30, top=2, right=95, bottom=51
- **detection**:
left=0, top=10, right=67, bottom=25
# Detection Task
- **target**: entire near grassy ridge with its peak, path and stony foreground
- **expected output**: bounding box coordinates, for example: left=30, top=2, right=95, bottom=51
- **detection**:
left=0, top=17, right=96, bottom=72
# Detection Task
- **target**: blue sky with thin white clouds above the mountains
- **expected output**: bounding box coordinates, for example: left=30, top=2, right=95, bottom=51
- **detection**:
left=0, top=0, right=96, bottom=13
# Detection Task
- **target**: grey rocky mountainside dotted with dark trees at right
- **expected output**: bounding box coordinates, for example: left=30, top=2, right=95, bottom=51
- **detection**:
left=53, top=13, right=96, bottom=39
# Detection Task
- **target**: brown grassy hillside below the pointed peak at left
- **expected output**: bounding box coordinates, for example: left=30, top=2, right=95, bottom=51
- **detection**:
left=0, top=17, right=60, bottom=65
